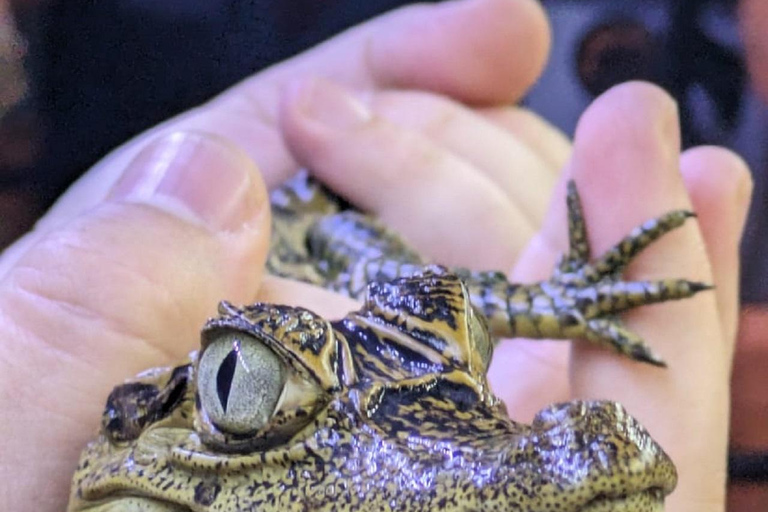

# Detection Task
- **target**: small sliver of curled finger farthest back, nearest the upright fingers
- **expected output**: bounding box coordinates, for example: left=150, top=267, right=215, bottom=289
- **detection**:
left=480, top=106, right=571, bottom=174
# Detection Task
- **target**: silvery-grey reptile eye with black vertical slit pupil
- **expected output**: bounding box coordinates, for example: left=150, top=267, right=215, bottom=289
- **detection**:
left=198, top=332, right=286, bottom=434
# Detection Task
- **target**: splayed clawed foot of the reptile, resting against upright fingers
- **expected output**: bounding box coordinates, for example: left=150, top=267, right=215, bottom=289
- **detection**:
left=541, top=181, right=712, bottom=366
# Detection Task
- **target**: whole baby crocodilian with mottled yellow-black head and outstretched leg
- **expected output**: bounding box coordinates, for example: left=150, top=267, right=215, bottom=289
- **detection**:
left=69, top=174, right=706, bottom=512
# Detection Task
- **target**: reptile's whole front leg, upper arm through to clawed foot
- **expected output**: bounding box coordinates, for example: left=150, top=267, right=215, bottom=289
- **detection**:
left=294, top=182, right=711, bottom=366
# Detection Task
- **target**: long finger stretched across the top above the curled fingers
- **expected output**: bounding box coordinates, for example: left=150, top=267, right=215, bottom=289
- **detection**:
left=28, top=0, right=549, bottom=236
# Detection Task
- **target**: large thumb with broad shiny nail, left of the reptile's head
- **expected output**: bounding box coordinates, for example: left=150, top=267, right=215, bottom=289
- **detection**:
left=0, top=134, right=269, bottom=510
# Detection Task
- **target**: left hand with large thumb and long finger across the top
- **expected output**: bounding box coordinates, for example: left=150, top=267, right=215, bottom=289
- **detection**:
left=0, top=0, right=549, bottom=511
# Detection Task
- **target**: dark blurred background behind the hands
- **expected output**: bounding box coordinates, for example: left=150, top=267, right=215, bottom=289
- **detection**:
left=0, top=0, right=768, bottom=512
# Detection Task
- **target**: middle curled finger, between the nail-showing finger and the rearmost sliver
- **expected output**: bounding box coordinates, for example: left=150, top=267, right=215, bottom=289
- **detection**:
left=368, top=91, right=560, bottom=225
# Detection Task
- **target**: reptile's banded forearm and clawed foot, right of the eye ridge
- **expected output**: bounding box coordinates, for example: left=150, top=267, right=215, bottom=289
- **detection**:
left=452, top=181, right=711, bottom=366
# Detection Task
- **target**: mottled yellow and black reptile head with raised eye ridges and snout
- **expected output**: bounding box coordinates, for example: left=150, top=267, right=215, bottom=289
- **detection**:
left=70, top=269, right=676, bottom=512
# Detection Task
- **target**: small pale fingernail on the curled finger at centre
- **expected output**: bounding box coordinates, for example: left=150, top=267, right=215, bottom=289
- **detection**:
left=288, top=79, right=371, bottom=131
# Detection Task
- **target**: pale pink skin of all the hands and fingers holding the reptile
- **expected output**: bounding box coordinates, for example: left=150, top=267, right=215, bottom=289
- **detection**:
left=0, top=0, right=751, bottom=512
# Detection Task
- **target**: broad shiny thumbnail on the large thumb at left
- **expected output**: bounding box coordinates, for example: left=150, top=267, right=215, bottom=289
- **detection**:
left=109, top=132, right=265, bottom=231
